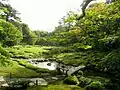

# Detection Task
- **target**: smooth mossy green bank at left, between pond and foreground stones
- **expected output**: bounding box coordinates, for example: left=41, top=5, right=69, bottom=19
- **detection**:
left=0, top=61, right=39, bottom=77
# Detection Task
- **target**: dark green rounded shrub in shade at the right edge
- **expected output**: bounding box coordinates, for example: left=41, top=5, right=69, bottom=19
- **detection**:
left=100, top=49, right=120, bottom=75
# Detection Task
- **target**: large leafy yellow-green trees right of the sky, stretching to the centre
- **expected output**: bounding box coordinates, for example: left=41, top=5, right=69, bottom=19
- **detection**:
left=35, top=1, right=120, bottom=50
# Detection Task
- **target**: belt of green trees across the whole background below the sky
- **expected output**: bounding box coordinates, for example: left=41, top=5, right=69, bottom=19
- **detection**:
left=0, top=0, right=120, bottom=46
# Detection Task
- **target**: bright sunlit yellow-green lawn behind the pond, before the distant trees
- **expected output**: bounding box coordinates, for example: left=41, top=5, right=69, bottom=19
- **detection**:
left=6, top=45, right=53, bottom=58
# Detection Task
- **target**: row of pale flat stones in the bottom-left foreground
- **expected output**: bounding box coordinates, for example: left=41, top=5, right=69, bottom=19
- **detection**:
left=0, top=76, right=48, bottom=87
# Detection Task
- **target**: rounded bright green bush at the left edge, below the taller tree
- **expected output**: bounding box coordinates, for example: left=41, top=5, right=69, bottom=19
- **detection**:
left=0, top=20, right=22, bottom=46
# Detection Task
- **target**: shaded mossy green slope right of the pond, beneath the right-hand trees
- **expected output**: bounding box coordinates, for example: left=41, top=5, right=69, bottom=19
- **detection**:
left=52, top=50, right=108, bottom=66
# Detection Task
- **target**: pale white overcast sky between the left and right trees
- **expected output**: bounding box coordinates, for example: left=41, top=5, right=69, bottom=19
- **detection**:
left=9, top=0, right=104, bottom=31
